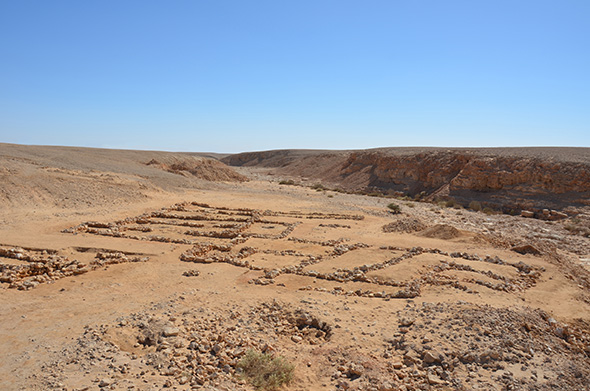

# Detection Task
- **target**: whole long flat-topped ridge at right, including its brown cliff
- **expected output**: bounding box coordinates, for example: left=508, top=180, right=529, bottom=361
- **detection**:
left=222, top=148, right=590, bottom=213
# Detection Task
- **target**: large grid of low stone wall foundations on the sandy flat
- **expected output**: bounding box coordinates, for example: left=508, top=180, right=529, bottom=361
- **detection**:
left=64, top=202, right=544, bottom=299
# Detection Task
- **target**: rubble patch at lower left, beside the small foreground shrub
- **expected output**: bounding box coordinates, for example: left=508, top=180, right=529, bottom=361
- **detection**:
left=37, top=302, right=332, bottom=390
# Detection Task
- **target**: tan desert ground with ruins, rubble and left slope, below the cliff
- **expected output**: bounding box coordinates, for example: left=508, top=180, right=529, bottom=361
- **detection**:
left=0, top=144, right=590, bottom=391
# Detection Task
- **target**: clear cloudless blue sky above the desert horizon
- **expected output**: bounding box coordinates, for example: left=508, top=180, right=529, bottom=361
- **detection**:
left=0, top=0, right=590, bottom=152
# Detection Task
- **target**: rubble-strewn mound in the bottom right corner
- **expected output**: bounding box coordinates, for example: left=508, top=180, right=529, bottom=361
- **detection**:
left=382, top=302, right=590, bottom=390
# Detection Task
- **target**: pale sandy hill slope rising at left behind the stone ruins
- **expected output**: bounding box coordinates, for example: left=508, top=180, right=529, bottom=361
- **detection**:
left=0, top=144, right=245, bottom=208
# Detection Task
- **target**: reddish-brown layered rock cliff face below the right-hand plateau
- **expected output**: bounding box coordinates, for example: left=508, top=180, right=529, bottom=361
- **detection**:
left=342, top=152, right=590, bottom=209
